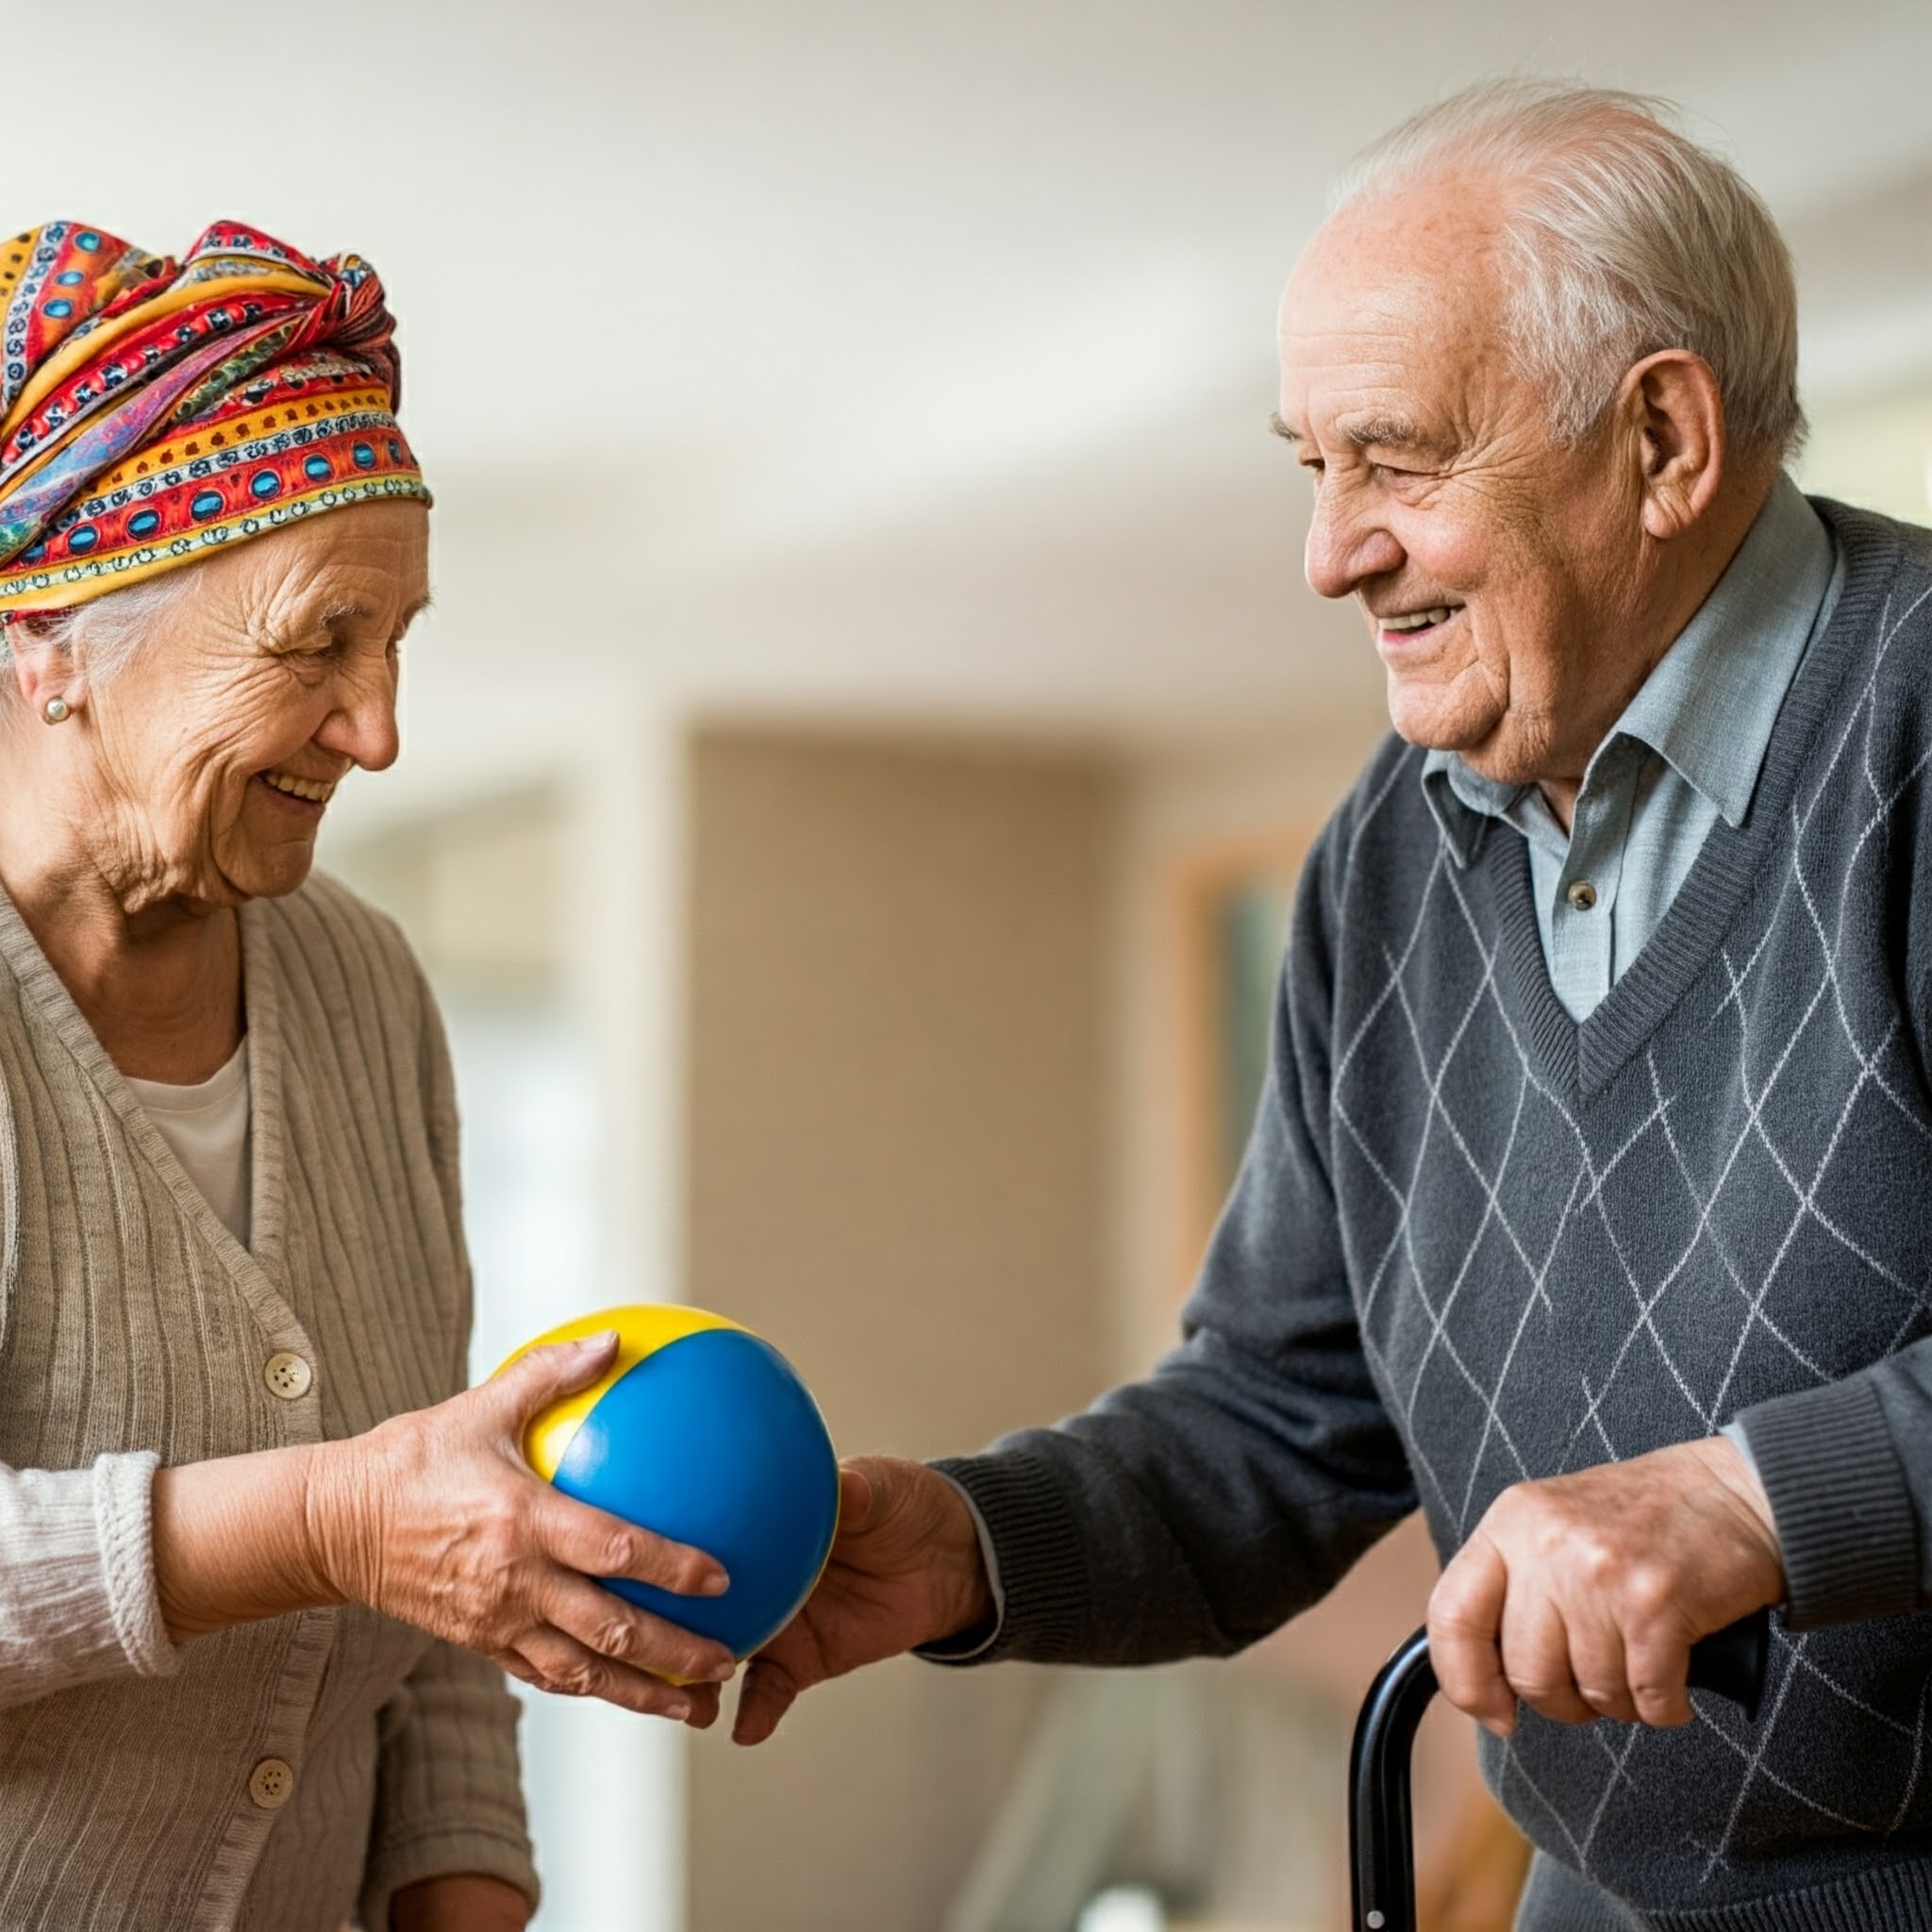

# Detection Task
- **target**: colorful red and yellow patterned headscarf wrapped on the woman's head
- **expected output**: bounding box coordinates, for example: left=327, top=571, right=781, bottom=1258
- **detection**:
left=0, top=223, right=429, bottom=614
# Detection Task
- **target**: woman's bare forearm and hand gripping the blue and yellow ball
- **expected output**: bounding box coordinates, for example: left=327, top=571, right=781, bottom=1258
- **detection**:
left=155, top=1335, right=736, bottom=1729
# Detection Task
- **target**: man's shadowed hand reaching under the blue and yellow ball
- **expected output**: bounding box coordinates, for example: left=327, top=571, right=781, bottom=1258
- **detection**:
left=732, top=1455, right=993, bottom=1744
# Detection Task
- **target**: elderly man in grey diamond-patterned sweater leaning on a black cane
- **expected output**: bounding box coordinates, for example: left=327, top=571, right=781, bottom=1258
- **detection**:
left=738, top=83, right=1932, bottom=1932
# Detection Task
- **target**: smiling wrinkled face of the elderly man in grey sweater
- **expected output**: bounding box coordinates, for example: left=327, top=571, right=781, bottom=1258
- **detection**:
left=1279, top=175, right=1641, bottom=784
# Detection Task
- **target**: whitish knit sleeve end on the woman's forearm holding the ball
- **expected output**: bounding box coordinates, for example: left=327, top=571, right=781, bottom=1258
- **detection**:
left=0, top=1451, right=179, bottom=1706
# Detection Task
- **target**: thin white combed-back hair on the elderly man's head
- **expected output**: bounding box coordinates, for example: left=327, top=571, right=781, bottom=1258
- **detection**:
left=1331, top=79, right=1805, bottom=458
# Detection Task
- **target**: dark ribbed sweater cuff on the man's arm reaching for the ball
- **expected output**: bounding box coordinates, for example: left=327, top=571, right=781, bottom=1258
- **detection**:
left=920, top=1449, right=1091, bottom=1663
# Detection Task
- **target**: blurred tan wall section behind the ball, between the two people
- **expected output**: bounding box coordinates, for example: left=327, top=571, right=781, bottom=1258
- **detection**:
left=688, top=732, right=1115, bottom=1932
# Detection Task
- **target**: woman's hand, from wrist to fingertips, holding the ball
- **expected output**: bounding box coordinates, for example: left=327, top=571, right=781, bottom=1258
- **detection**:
left=309, top=1335, right=736, bottom=1725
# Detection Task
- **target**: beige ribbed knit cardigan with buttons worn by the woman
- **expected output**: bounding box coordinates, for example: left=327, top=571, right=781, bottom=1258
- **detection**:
left=0, top=879, right=535, bottom=1932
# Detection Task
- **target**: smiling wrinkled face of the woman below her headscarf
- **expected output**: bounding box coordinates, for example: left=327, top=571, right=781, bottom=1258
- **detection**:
left=71, top=502, right=429, bottom=912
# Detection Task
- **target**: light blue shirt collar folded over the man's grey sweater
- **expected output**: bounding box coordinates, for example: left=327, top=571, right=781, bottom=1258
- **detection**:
left=1422, top=472, right=1838, bottom=866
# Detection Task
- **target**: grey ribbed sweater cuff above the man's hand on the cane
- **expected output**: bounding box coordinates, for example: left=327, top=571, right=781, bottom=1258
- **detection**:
left=1737, top=1375, right=1919, bottom=1631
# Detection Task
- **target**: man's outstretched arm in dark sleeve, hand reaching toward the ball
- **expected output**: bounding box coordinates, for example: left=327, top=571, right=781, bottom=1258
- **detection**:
left=736, top=815, right=1416, bottom=1742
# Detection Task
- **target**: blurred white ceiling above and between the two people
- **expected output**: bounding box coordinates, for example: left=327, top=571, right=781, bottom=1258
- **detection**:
left=0, top=0, right=1932, bottom=819
